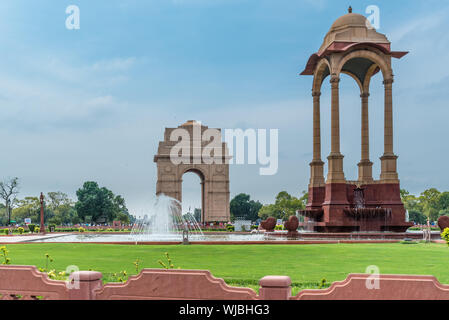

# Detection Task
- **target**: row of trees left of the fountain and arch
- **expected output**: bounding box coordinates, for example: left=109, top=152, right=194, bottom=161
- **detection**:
left=0, top=177, right=135, bottom=226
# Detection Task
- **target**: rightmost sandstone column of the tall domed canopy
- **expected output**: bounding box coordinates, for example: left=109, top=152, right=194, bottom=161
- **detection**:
left=380, top=78, right=398, bottom=183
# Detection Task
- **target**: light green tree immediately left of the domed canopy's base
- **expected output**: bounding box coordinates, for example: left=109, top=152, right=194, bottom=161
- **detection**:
left=259, top=191, right=308, bottom=220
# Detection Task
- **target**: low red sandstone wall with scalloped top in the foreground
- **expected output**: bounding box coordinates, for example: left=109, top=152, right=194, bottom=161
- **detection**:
left=0, top=265, right=449, bottom=300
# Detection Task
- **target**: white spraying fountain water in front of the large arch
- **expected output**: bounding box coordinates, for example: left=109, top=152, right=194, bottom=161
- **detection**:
left=130, top=194, right=204, bottom=242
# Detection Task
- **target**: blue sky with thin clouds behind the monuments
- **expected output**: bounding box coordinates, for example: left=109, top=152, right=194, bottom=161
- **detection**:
left=0, top=0, right=449, bottom=214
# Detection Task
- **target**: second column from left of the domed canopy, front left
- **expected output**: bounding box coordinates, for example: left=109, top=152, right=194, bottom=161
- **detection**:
left=327, top=76, right=346, bottom=183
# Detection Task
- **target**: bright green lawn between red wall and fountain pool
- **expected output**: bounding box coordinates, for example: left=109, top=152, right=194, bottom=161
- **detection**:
left=6, top=243, right=449, bottom=291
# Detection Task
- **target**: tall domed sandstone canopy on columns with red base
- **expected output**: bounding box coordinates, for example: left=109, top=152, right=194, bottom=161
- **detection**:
left=299, top=7, right=411, bottom=232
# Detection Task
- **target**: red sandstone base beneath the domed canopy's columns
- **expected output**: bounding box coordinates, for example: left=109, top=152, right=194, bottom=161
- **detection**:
left=299, top=183, right=413, bottom=233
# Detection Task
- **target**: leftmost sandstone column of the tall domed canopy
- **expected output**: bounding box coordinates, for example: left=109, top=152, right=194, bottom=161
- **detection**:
left=309, top=91, right=324, bottom=186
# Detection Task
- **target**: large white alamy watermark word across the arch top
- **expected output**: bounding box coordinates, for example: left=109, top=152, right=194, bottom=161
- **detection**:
left=170, top=122, right=279, bottom=175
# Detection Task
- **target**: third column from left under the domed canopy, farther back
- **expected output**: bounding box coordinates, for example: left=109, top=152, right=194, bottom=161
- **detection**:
left=358, top=92, right=373, bottom=182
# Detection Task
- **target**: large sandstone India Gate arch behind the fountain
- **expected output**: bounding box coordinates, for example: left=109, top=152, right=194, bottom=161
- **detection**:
left=154, top=120, right=230, bottom=222
